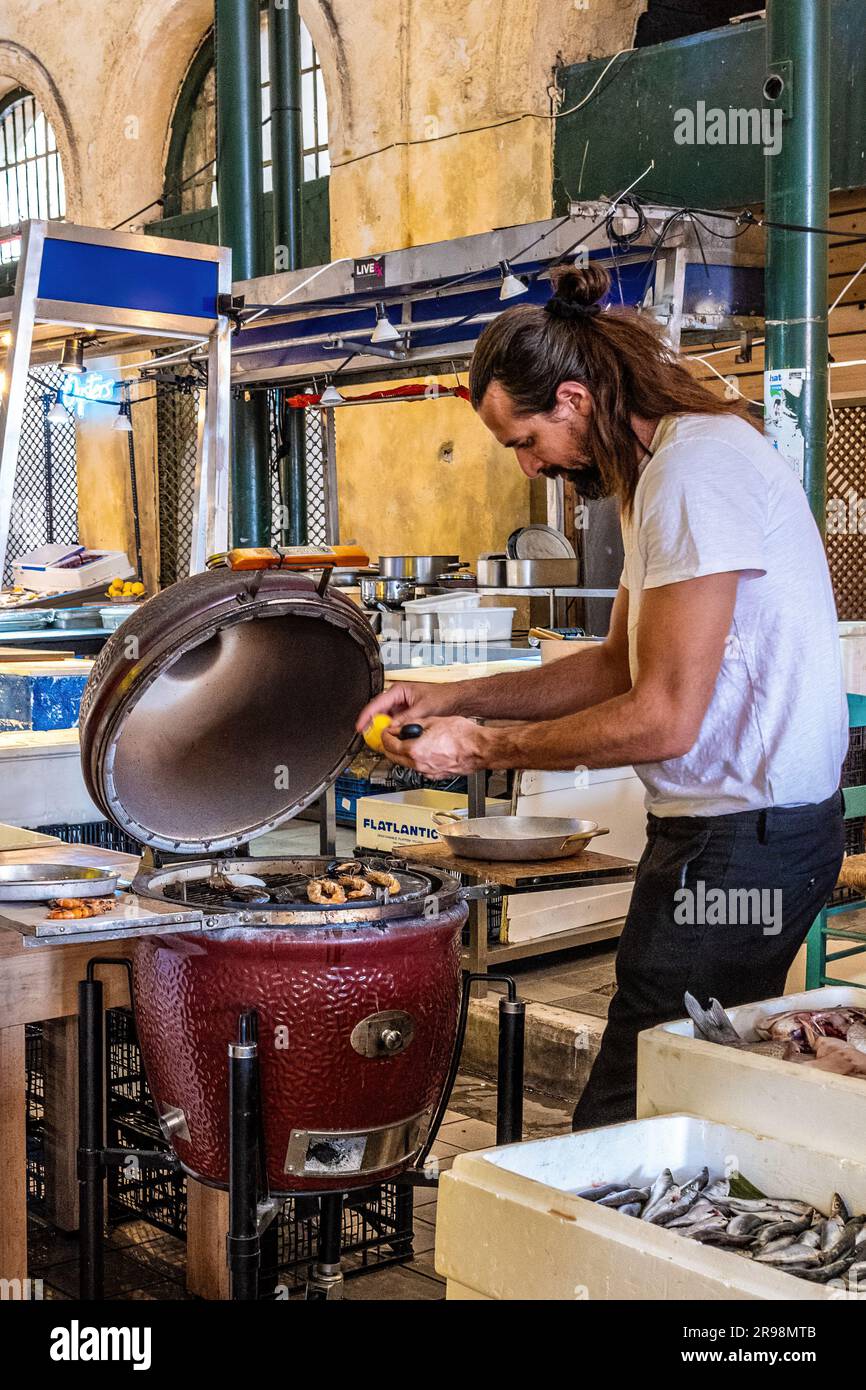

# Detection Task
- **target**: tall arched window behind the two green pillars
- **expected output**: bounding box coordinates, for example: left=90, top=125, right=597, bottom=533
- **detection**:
left=163, top=11, right=331, bottom=217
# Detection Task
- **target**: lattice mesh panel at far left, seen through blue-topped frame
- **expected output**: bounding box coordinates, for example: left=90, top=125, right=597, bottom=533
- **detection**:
left=3, top=367, right=78, bottom=584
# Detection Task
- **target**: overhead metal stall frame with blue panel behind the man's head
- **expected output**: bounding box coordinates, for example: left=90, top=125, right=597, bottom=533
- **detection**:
left=232, top=203, right=763, bottom=386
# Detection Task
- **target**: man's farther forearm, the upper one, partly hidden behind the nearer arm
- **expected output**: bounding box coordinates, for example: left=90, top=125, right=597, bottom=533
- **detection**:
left=430, top=644, right=630, bottom=721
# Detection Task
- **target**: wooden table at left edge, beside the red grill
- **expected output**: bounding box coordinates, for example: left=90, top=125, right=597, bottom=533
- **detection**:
left=0, top=826, right=228, bottom=1298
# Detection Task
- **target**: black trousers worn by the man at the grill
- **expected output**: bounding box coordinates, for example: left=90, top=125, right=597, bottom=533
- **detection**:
left=574, top=792, right=845, bottom=1130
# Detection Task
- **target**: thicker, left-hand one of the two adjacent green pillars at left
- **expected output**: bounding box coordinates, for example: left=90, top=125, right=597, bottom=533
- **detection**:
left=214, top=0, right=271, bottom=546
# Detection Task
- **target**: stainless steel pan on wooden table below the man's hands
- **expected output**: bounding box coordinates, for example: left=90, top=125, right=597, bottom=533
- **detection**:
left=434, top=810, right=609, bottom=863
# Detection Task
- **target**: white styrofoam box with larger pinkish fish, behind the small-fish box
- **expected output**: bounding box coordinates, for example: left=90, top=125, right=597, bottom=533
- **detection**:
left=638, top=986, right=866, bottom=1161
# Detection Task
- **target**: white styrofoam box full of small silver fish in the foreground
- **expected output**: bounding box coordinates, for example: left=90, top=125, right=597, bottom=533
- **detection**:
left=435, top=1113, right=866, bottom=1301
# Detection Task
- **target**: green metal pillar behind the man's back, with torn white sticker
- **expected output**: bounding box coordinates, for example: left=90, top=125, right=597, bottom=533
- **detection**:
left=765, top=0, right=831, bottom=530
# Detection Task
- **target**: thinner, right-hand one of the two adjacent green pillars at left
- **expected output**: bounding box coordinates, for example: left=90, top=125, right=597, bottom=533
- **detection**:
left=268, top=0, right=309, bottom=545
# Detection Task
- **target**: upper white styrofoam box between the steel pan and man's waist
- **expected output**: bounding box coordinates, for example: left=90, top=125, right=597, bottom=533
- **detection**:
left=517, top=767, right=646, bottom=860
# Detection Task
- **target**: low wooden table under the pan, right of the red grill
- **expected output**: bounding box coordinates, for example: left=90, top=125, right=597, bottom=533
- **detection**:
left=399, top=840, right=635, bottom=998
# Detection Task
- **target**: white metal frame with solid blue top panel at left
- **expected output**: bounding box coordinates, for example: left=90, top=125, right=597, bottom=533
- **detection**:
left=0, top=221, right=231, bottom=573
